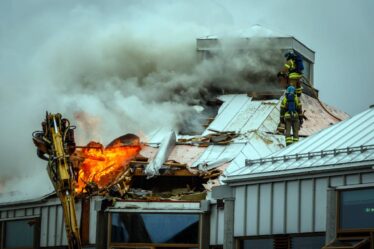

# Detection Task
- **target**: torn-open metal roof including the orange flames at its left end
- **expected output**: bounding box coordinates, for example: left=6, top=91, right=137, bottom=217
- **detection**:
left=0, top=94, right=348, bottom=205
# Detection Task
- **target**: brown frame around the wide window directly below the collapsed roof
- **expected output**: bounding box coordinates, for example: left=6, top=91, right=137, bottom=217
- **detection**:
left=107, top=211, right=202, bottom=249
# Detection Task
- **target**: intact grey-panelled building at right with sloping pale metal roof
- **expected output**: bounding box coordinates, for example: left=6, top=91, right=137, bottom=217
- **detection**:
left=225, top=106, right=374, bottom=249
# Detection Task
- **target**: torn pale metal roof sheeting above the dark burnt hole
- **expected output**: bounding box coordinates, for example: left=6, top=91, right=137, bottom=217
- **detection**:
left=0, top=94, right=348, bottom=202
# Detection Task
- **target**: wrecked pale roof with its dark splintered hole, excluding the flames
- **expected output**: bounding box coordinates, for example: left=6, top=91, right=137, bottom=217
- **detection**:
left=72, top=94, right=348, bottom=200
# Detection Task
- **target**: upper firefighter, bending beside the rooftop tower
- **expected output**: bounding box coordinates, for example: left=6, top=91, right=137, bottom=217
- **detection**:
left=278, top=51, right=304, bottom=97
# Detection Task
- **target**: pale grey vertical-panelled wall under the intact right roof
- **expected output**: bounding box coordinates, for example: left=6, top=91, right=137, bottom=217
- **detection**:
left=234, top=172, right=374, bottom=237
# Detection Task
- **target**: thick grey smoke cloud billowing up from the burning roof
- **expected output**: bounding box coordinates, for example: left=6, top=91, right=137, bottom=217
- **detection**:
left=32, top=20, right=282, bottom=142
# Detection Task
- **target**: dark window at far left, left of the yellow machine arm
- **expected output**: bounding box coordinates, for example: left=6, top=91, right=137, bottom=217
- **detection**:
left=3, top=219, right=37, bottom=248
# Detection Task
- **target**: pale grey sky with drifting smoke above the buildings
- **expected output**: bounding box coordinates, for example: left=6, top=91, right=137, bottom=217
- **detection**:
left=0, top=0, right=374, bottom=197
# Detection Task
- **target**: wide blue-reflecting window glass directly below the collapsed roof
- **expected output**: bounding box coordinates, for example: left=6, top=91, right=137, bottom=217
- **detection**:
left=111, top=213, right=199, bottom=247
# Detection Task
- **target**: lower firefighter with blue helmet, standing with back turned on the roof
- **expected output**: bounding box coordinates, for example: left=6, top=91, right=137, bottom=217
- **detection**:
left=280, top=86, right=303, bottom=146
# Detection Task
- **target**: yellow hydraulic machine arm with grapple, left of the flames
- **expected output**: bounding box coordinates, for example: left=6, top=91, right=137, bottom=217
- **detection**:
left=33, top=112, right=81, bottom=249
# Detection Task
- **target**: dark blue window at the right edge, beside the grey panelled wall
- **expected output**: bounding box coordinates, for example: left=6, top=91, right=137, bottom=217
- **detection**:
left=339, top=188, right=374, bottom=230
